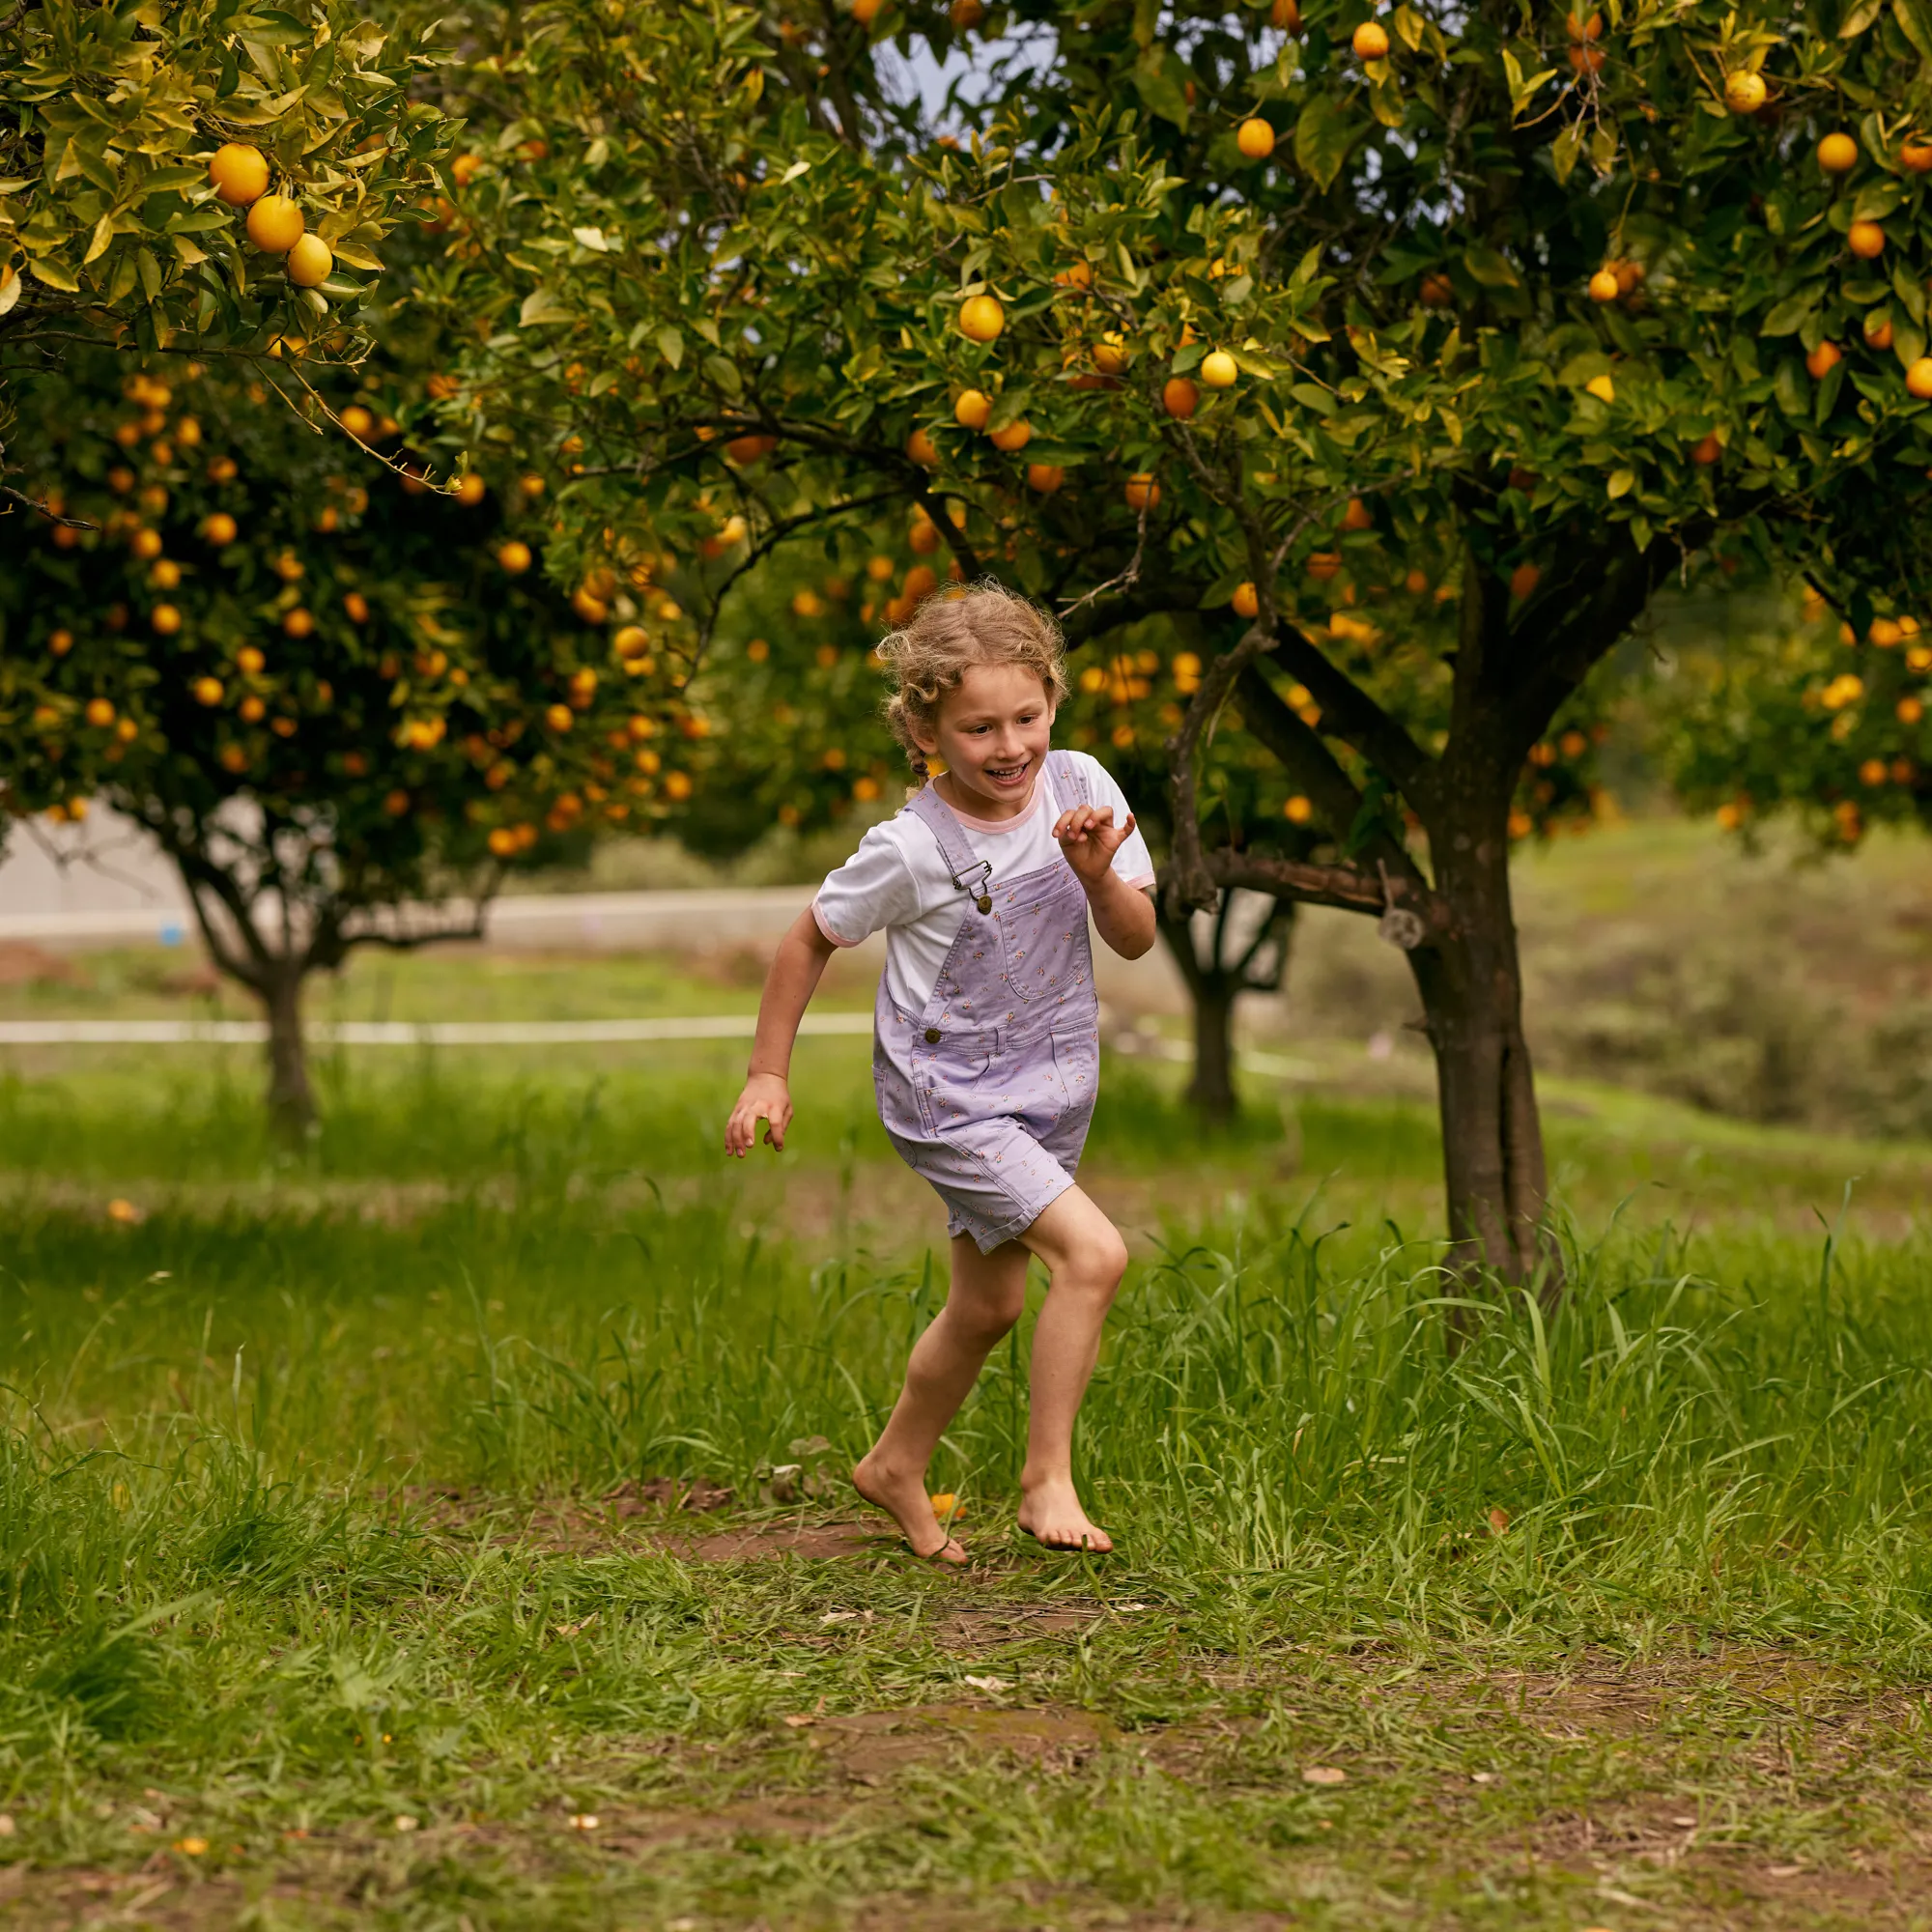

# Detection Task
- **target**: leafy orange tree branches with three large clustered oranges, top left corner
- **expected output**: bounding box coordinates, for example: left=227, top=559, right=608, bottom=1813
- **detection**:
left=0, top=0, right=446, bottom=392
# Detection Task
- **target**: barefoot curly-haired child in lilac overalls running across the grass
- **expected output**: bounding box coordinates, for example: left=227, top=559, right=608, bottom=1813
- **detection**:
left=724, top=585, right=1153, bottom=1563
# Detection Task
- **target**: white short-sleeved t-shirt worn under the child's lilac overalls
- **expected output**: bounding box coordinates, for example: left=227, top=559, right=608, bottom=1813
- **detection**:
left=811, top=752, right=1153, bottom=1012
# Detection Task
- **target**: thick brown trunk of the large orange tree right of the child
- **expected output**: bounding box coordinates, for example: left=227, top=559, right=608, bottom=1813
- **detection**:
left=1408, top=800, right=1561, bottom=1300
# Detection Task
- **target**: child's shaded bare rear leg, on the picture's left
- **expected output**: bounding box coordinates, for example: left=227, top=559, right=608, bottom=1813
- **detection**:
left=852, top=1235, right=1032, bottom=1563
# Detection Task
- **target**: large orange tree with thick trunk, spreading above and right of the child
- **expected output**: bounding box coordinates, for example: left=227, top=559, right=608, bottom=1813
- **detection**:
left=400, top=0, right=1932, bottom=1279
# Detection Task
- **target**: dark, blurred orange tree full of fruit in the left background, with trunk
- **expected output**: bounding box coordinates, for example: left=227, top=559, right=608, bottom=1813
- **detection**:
left=0, top=355, right=690, bottom=1128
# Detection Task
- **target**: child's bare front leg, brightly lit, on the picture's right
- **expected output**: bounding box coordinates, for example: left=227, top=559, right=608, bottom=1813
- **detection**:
left=1001, top=1188, right=1126, bottom=1549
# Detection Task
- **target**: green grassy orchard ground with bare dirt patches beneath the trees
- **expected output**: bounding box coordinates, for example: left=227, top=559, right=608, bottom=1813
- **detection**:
left=0, top=829, right=1932, bottom=1932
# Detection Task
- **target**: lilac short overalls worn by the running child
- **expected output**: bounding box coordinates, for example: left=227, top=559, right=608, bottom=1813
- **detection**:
left=871, top=752, right=1099, bottom=1254
